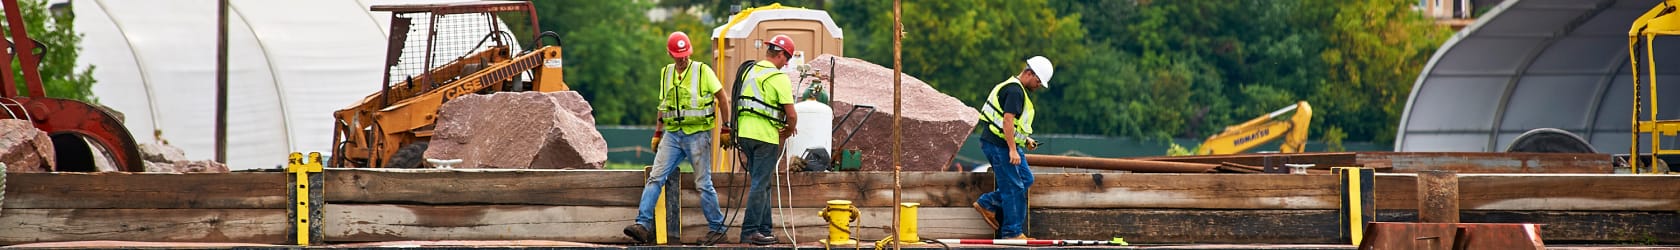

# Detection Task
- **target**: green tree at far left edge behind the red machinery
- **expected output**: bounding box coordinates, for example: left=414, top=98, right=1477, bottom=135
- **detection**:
left=0, top=0, right=97, bottom=102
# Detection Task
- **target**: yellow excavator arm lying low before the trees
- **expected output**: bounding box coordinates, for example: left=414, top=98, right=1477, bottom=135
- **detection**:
left=1196, top=101, right=1312, bottom=154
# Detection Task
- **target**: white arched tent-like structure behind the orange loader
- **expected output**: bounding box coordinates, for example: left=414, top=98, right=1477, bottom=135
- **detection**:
left=69, top=0, right=510, bottom=169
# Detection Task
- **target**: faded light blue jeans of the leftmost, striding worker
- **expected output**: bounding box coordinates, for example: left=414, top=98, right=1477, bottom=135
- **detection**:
left=635, top=131, right=724, bottom=232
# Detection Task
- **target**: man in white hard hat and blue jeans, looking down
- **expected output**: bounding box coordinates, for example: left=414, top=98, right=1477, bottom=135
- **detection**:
left=973, top=57, right=1055, bottom=238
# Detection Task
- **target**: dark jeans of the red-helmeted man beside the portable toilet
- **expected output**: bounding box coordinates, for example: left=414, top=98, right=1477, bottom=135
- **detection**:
left=741, top=138, right=781, bottom=238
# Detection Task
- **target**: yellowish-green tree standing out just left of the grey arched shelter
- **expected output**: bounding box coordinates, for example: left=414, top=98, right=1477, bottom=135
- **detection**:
left=1312, top=0, right=1452, bottom=144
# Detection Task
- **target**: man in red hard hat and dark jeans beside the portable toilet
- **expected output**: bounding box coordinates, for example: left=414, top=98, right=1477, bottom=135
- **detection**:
left=736, top=35, right=800, bottom=245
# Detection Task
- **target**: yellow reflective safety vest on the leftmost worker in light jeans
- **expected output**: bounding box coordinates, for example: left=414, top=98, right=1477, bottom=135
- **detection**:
left=659, top=60, right=714, bottom=124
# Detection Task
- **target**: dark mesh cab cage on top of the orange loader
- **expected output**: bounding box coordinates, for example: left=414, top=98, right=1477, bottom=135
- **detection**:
left=371, top=2, right=538, bottom=92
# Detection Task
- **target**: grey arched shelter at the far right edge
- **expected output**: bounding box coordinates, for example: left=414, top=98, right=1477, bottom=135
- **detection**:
left=1394, top=0, right=1680, bottom=154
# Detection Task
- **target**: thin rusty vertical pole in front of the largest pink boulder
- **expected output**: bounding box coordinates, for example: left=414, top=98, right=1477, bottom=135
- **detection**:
left=892, top=0, right=904, bottom=250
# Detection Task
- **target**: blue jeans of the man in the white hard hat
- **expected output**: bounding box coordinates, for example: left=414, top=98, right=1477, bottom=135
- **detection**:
left=978, top=141, right=1033, bottom=238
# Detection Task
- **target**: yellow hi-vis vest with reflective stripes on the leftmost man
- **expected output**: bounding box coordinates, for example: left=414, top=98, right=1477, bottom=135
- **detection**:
left=659, top=60, right=714, bottom=129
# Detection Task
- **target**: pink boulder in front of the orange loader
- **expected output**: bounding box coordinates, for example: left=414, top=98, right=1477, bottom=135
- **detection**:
left=425, top=91, right=606, bottom=169
